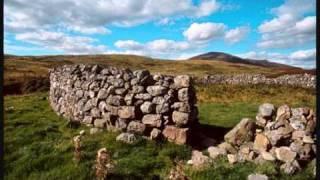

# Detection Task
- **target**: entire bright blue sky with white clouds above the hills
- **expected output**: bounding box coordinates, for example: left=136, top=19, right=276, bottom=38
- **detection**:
left=4, top=0, right=316, bottom=68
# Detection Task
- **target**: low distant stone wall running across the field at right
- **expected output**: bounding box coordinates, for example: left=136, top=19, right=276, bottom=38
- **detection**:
left=197, top=74, right=316, bottom=88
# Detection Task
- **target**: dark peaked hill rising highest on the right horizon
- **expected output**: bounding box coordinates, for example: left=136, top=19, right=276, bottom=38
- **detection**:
left=190, top=52, right=301, bottom=69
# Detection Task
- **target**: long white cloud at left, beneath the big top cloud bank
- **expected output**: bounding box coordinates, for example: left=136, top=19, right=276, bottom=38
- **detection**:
left=16, top=31, right=107, bottom=54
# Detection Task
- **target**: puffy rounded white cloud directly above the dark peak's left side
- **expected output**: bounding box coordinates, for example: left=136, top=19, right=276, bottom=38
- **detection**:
left=183, top=22, right=226, bottom=44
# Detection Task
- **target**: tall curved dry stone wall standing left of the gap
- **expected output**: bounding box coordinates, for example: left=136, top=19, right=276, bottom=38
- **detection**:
left=50, top=64, right=198, bottom=144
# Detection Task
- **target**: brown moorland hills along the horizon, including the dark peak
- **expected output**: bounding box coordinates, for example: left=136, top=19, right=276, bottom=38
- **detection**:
left=4, top=53, right=315, bottom=93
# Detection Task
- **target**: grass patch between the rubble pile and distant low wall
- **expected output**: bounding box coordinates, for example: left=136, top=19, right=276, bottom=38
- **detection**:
left=196, top=84, right=316, bottom=128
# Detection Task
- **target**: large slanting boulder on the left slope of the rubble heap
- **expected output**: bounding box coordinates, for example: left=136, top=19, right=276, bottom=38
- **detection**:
left=224, top=118, right=255, bottom=146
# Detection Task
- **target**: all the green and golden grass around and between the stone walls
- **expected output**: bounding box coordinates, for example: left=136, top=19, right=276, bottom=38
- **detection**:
left=4, top=85, right=315, bottom=179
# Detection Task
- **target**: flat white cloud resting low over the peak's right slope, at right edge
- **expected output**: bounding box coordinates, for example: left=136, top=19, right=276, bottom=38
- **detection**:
left=236, top=49, right=316, bottom=68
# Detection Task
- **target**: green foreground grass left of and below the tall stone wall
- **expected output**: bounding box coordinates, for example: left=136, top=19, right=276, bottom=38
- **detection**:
left=4, top=93, right=191, bottom=179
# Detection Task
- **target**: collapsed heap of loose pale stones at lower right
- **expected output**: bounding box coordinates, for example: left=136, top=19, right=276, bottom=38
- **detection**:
left=188, top=103, right=316, bottom=174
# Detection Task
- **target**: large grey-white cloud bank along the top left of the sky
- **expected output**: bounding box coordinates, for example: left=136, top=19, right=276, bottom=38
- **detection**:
left=4, top=0, right=219, bottom=33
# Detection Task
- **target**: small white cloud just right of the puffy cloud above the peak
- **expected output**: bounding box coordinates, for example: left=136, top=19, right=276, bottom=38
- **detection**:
left=224, top=26, right=250, bottom=44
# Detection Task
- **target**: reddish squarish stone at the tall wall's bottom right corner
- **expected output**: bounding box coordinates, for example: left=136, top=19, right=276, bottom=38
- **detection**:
left=162, top=125, right=189, bottom=144
